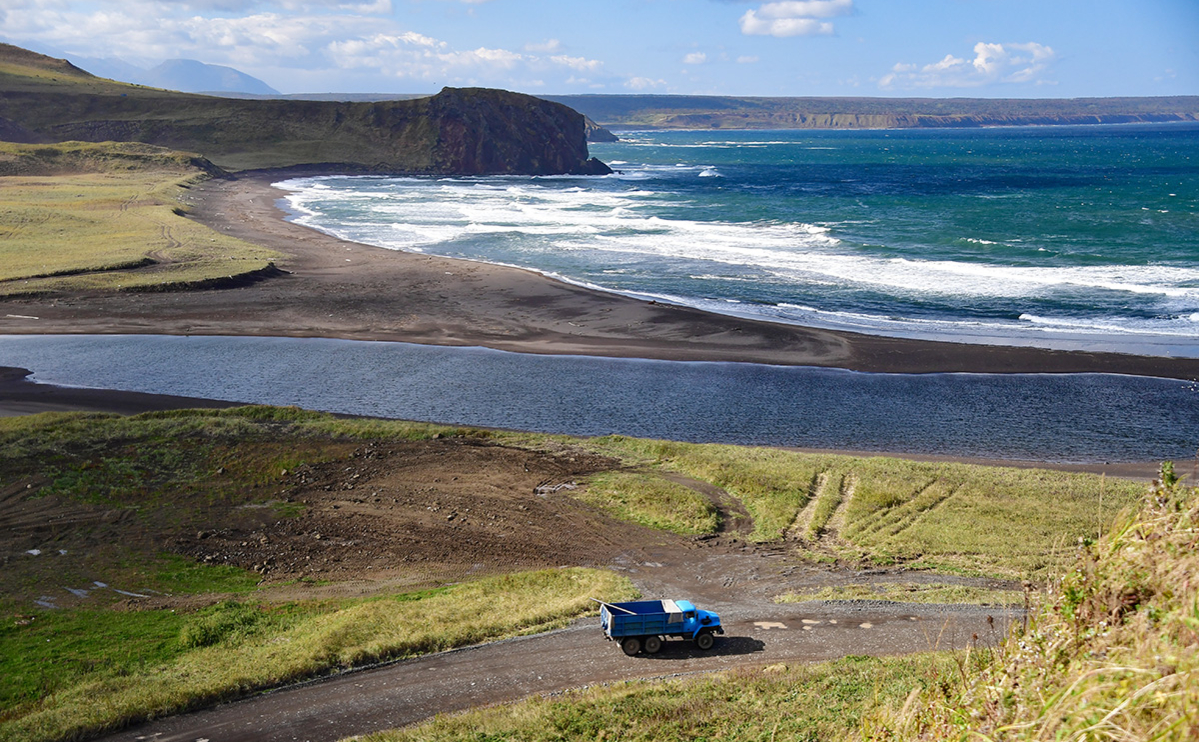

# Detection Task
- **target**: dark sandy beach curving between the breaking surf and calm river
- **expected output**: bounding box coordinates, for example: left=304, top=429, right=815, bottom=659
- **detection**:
left=0, top=171, right=1199, bottom=379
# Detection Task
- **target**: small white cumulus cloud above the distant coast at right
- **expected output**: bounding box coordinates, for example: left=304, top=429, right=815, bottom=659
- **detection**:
left=879, top=42, right=1056, bottom=89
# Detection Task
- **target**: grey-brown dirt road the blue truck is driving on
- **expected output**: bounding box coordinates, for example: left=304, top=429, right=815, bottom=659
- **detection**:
left=106, top=544, right=1018, bottom=742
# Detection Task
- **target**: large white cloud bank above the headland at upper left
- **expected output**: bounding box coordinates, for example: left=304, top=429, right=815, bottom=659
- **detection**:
left=0, top=0, right=618, bottom=91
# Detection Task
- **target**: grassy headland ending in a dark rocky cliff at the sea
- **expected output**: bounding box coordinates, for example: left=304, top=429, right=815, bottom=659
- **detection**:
left=0, top=44, right=610, bottom=175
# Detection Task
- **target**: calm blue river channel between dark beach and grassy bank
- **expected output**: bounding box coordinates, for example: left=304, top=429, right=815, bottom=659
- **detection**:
left=0, top=336, right=1199, bottom=462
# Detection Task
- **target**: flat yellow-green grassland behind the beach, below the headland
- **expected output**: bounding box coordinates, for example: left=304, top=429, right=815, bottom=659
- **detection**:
left=0, top=143, right=282, bottom=296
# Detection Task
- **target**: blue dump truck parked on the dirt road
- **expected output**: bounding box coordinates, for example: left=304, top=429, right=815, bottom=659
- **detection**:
left=591, top=598, right=724, bottom=657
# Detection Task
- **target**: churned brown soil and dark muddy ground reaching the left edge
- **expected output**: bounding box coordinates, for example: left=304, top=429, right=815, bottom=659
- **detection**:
left=0, top=438, right=693, bottom=608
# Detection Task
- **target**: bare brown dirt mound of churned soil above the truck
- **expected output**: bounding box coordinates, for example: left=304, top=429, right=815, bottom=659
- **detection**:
left=175, top=439, right=685, bottom=585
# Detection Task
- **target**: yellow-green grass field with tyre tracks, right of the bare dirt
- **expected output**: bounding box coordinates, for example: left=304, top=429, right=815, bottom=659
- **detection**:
left=584, top=436, right=1143, bottom=578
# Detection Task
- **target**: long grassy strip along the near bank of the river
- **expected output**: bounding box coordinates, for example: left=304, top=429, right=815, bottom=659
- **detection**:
left=0, top=406, right=1141, bottom=587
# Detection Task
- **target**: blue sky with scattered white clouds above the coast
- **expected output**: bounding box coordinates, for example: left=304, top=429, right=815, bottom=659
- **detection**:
left=0, top=0, right=1199, bottom=98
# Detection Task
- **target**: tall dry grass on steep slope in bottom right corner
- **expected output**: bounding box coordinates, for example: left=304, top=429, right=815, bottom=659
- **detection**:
left=861, top=465, right=1199, bottom=741
